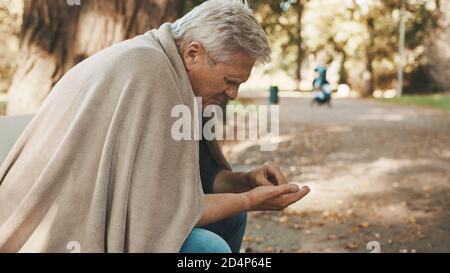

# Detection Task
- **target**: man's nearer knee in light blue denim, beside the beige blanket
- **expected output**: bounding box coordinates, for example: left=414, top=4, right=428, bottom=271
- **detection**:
left=180, top=228, right=231, bottom=253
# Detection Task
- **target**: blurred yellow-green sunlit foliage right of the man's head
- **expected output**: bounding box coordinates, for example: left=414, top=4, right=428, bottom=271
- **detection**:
left=252, top=0, right=437, bottom=92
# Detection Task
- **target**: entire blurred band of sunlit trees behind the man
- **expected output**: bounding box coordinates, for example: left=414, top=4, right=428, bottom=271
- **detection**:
left=0, top=0, right=450, bottom=114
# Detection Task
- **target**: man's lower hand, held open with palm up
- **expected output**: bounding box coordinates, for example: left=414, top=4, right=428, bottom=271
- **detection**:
left=243, top=184, right=310, bottom=211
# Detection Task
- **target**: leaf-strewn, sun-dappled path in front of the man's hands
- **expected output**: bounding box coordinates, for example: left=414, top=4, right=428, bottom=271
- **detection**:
left=225, top=98, right=450, bottom=252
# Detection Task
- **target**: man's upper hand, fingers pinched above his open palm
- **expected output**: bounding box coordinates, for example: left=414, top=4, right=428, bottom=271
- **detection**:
left=246, top=162, right=288, bottom=189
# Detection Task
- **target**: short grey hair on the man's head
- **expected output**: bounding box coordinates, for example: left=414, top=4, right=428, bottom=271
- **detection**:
left=171, top=0, right=271, bottom=63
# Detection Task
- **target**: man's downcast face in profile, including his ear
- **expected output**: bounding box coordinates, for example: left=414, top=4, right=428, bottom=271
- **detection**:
left=183, top=42, right=255, bottom=107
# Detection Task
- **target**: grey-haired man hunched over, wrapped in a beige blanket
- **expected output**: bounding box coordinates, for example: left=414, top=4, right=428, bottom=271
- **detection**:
left=0, top=0, right=309, bottom=252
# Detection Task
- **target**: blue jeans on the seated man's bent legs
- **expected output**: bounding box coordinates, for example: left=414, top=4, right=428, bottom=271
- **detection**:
left=180, top=210, right=247, bottom=253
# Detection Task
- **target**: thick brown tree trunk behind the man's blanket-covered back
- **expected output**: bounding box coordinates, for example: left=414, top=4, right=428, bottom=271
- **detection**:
left=7, top=0, right=185, bottom=115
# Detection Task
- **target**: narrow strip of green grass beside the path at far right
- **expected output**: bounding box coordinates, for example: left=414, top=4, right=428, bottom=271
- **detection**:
left=378, top=93, right=450, bottom=111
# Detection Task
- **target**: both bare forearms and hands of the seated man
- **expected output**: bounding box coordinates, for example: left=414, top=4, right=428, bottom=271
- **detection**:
left=202, top=159, right=310, bottom=223
